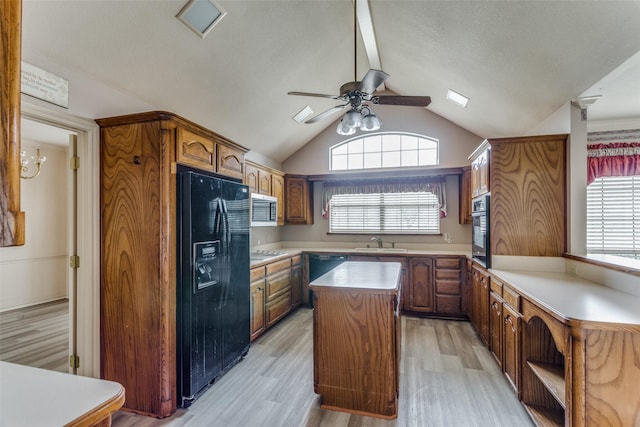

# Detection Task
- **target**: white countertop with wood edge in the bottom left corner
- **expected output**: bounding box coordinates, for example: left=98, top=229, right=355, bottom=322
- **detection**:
left=0, top=362, right=124, bottom=427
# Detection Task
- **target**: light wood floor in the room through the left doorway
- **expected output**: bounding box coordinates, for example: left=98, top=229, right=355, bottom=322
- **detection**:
left=0, top=299, right=69, bottom=372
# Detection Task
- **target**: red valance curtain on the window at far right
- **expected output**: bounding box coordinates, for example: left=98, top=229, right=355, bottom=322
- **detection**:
left=587, top=129, right=640, bottom=185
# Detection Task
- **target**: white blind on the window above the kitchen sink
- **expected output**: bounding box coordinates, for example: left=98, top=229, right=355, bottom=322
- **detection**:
left=329, top=192, right=440, bottom=234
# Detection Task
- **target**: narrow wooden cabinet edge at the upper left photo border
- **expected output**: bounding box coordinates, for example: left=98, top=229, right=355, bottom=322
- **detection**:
left=0, top=0, right=24, bottom=246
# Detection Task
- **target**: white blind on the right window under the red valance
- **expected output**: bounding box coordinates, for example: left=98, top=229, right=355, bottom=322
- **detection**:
left=587, top=176, right=640, bottom=259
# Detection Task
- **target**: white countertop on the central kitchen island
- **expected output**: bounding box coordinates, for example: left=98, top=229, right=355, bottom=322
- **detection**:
left=309, top=261, right=402, bottom=290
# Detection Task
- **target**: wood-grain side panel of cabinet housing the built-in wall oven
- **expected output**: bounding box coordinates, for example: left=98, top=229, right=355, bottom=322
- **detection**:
left=489, top=135, right=567, bottom=257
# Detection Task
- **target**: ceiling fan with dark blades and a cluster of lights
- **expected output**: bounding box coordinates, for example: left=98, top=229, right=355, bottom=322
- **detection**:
left=288, top=0, right=431, bottom=135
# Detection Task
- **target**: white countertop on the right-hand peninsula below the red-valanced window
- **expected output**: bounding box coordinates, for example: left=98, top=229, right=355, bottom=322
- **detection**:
left=489, top=269, right=640, bottom=325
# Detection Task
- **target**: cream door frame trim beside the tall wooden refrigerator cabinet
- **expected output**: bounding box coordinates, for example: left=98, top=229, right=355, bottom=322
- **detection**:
left=21, top=98, right=100, bottom=378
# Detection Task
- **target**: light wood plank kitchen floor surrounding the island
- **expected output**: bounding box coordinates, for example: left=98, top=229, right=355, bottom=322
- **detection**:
left=112, top=308, right=533, bottom=427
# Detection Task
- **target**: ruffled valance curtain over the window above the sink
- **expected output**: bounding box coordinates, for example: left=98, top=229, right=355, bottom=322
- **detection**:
left=322, top=179, right=447, bottom=219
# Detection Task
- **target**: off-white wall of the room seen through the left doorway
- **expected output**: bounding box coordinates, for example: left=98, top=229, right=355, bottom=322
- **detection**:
left=0, top=140, right=69, bottom=311
